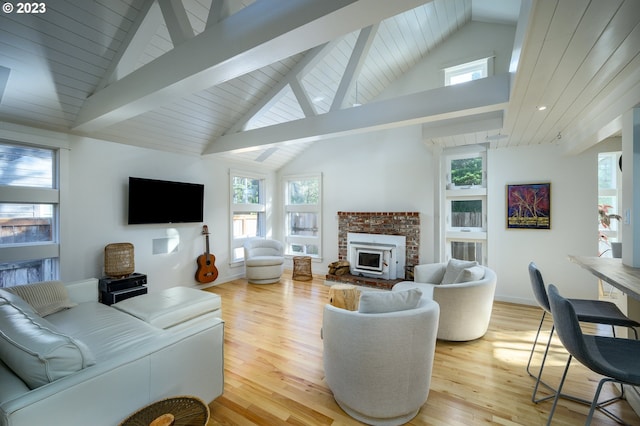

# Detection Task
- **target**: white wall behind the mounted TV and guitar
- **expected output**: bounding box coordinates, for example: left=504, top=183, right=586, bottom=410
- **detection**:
left=60, top=139, right=274, bottom=291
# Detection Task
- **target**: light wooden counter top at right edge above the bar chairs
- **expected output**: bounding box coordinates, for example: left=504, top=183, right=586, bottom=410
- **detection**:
left=569, top=255, right=640, bottom=300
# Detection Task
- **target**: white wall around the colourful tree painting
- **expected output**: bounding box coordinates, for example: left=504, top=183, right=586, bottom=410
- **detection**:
left=488, top=145, right=598, bottom=304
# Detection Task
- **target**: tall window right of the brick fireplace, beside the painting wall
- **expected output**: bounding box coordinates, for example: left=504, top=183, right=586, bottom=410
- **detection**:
left=444, top=151, right=487, bottom=264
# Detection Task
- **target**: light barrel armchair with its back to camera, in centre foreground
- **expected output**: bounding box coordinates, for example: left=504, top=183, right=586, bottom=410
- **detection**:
left=322, top=292, right=439, bottom=425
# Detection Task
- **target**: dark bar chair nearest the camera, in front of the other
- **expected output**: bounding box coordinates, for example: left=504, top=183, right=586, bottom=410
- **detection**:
left=547, top=284, right=640, bottom=425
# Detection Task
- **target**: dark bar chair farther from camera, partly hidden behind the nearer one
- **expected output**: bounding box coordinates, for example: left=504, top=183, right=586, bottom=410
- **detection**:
left=527, top=262, right=640, bottom=403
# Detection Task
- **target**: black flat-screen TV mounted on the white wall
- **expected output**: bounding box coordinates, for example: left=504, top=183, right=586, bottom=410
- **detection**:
left=128, top=177, right=204, bottom=225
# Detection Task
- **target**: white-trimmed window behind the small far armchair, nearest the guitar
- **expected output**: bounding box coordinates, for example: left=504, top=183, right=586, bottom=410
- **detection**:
left=229, top=170, right=267, bottom=263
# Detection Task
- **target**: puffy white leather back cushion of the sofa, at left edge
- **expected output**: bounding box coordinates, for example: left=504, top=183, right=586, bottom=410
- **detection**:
left=0, top=298, right=95, bottom=389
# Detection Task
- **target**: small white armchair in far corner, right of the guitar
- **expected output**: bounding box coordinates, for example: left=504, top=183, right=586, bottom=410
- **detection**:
left=244, top=238, right=284, bottom=284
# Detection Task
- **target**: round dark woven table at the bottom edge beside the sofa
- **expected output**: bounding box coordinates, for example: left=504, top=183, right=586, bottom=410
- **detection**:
left=120, top=396, right=209, bottom=426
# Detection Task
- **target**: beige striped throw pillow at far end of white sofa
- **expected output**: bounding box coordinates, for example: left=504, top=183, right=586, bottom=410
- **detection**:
left=5, top=281, right=76, bottom=317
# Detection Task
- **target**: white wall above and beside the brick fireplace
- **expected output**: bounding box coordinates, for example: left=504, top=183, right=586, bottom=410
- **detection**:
left=278, top=126, right=434, bottom=274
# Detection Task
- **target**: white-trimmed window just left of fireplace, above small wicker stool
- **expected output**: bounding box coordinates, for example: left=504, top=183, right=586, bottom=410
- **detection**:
left=284, top=174, right=322, bottom=258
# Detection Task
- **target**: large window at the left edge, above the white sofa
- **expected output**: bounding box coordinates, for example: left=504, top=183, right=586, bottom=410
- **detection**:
left=0, top=143, right=60, bottom=287
